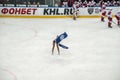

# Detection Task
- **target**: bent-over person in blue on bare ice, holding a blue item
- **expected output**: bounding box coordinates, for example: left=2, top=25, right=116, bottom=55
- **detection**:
left=52, top=32, right=68, bottom=55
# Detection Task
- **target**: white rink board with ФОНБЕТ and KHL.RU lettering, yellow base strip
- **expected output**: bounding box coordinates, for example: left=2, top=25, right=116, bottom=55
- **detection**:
left=0, top=7, right=120, bottom=18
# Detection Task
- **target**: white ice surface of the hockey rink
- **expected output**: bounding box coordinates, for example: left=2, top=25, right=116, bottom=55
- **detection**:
left=0, top=18, right=120, bottom=80
